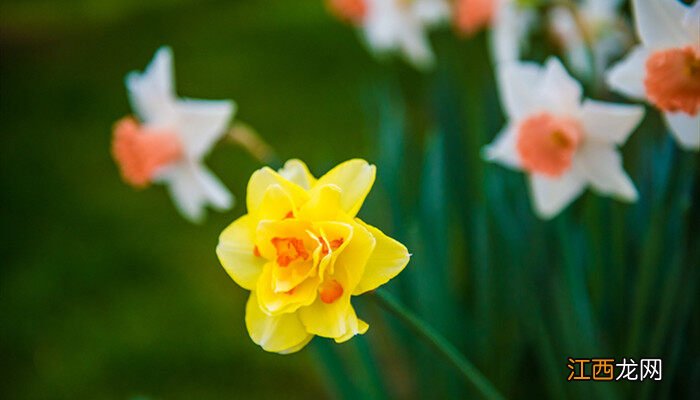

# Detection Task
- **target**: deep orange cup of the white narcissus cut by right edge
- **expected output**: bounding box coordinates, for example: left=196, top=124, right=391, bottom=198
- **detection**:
left=644, top=46, right=700, bottom=115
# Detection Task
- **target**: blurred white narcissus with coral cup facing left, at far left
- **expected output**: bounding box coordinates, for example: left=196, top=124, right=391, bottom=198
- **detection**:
left=112, top=47, right=236, bottom=221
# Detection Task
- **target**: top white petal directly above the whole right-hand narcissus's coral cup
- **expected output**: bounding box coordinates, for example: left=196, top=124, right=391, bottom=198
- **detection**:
left=530, top=57, right=583, bottom=115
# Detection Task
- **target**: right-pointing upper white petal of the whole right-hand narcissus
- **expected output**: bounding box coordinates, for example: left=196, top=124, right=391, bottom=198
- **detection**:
left=581, top=99, right=644, bottom=144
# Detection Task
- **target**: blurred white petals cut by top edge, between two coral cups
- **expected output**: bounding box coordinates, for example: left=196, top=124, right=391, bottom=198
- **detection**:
left=360, top=0, right=450, bottom=68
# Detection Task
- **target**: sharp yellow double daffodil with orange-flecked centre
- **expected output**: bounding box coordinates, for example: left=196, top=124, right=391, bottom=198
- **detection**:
left=216, top=160, right=409, bottom=354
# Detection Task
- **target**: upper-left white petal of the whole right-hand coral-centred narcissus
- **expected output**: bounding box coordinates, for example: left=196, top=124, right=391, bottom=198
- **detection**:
left=497, top=62, right=543, bottom=119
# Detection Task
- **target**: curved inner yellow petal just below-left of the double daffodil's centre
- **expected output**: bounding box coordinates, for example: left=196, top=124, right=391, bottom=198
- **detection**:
left=256, top=263, right=318, bottom=315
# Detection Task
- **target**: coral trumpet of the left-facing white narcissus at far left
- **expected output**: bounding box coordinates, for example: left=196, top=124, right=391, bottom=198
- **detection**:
left=112, top=117, right=183, bottom=187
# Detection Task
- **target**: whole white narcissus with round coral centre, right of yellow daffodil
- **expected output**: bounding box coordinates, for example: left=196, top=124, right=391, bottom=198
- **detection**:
left=484, top=58, right=644, bottom=218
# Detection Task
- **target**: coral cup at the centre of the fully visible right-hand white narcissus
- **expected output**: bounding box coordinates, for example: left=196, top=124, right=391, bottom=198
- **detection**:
left=516, top=113, right=583, bottom=177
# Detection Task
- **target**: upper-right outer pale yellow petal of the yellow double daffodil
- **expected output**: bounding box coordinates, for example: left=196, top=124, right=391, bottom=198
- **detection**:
left=312, top=159, right=376, bottom=217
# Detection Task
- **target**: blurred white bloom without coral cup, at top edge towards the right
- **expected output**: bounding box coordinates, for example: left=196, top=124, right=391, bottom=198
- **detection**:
left=549, top=0, right=631, bottom=75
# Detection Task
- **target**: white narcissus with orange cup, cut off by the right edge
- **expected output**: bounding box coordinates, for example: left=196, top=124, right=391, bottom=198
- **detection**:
left=608, top=0, right=700, bottom=150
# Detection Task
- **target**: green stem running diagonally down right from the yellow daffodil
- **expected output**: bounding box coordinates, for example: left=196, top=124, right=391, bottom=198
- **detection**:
left=372, top=289, right=504, bottom=399
